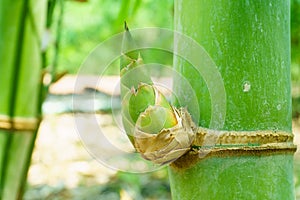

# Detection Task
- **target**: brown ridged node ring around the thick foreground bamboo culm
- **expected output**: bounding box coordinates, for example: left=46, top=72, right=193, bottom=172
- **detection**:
left=171, top=127, right=297, bottom=169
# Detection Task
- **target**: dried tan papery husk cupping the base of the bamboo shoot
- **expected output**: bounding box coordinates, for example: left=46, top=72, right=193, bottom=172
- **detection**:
left=134, top=107, right=196, bottom=164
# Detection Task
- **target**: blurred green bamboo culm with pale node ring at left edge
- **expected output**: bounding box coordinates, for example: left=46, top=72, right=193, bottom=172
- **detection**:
left=0, top=0, right=46, bottom=200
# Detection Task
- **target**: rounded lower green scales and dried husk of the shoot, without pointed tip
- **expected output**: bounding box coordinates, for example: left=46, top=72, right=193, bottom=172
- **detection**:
left=129, top=84, right=195, bottom=164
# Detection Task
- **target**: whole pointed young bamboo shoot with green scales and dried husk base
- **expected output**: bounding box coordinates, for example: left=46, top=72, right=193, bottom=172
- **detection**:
left=120, top=24, right=195, bottom=164
